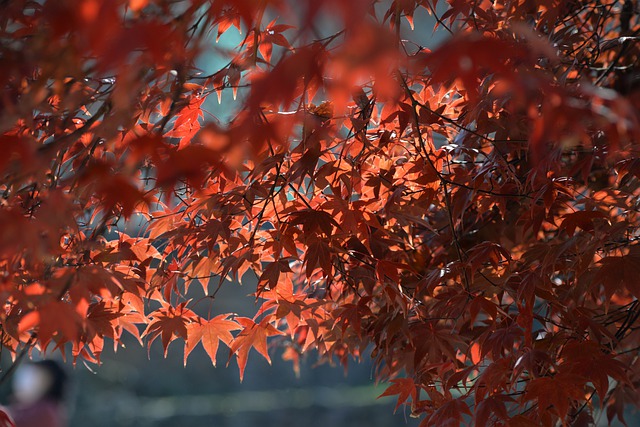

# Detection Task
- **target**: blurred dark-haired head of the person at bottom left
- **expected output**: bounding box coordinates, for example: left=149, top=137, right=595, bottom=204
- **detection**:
left=13, top=360, right=67, bottom=404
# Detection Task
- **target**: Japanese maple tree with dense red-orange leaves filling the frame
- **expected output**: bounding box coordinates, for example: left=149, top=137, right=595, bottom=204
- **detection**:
left=0, top=0, right=640, bottom=426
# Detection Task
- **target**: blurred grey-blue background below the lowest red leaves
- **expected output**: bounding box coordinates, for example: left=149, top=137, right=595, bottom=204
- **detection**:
left=0, top=310, right=419, bottom=427
